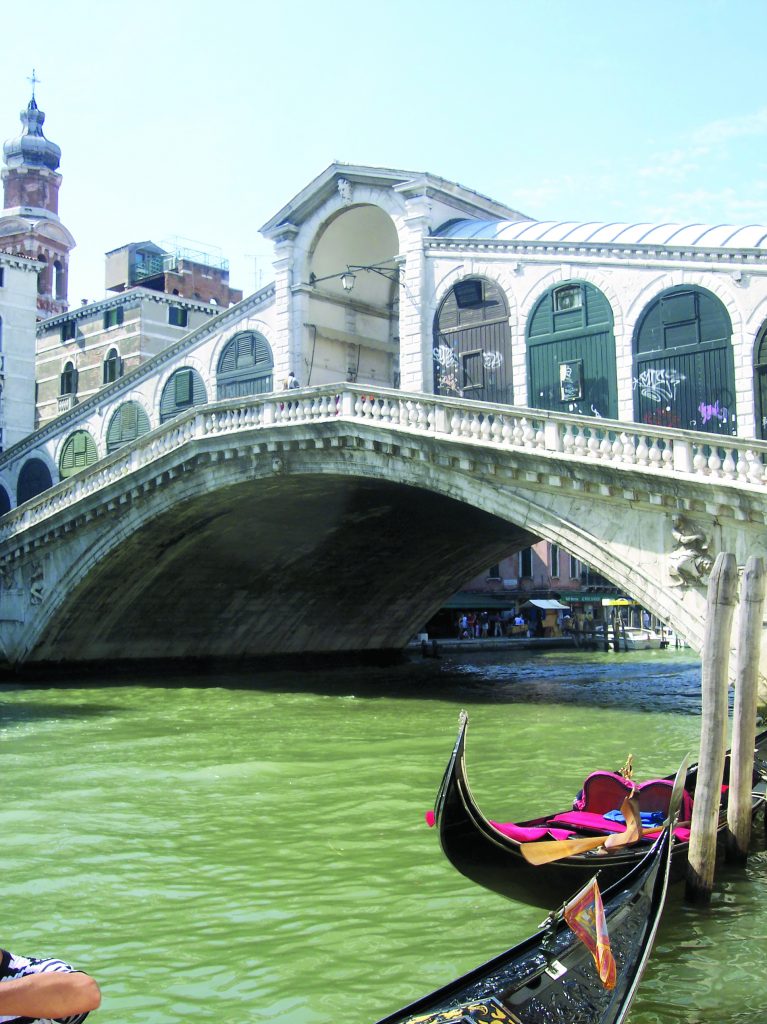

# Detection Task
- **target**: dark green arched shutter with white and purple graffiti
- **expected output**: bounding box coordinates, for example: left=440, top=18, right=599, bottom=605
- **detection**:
left=634, top=285, right=735, bottom=434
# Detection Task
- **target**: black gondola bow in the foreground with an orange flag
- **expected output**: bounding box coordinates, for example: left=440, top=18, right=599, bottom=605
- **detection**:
left=378, top=811, right=671, bottom=1024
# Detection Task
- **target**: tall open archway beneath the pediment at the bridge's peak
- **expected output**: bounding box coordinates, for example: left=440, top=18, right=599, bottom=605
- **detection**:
left=303, top=205, right=399, bottom=387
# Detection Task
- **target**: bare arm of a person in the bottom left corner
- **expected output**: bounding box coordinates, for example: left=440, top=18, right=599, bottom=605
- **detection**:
left=0, top=971, right=101, bottom=1017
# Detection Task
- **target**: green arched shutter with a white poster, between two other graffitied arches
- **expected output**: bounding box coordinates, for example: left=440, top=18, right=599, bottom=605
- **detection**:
left=526, top=281, right=617, bottom=419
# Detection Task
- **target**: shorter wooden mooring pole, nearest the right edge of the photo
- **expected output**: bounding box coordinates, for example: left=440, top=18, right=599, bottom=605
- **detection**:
left=726, top=557, right=767, bottom=864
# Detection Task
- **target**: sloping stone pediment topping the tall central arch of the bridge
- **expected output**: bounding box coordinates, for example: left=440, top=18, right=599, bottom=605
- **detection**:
left=260, top=163, right=523, bottom=240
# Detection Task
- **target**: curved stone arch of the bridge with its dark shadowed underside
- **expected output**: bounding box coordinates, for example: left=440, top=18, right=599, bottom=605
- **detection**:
left=16, top=442, right=694, bottom=662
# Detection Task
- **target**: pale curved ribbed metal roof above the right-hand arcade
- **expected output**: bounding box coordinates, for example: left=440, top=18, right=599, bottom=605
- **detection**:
left=432, top=220, right=767, bottom=250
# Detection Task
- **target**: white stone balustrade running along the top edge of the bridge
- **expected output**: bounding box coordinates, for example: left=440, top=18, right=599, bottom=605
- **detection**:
left=0, top=384, right=767, bottom=543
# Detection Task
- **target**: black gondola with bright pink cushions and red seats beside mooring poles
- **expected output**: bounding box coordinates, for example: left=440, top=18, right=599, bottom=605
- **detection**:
left=433, top=712, right=767, bottom=907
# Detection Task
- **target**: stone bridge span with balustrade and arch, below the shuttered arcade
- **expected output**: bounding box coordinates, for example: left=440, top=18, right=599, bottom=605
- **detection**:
left=0, top=385, right=767, bottom=696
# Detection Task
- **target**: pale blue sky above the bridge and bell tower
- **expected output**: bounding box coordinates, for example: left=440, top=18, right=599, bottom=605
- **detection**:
left=0, top=0, right=767, bottom=306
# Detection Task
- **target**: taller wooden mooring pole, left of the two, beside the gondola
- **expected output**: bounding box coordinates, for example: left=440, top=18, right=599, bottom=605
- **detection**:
left=685, top=552, right=737, bottom=903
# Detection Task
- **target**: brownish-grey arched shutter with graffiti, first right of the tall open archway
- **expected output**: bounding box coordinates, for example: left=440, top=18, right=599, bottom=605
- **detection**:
left=433, top=278, right=513, bottom=403
